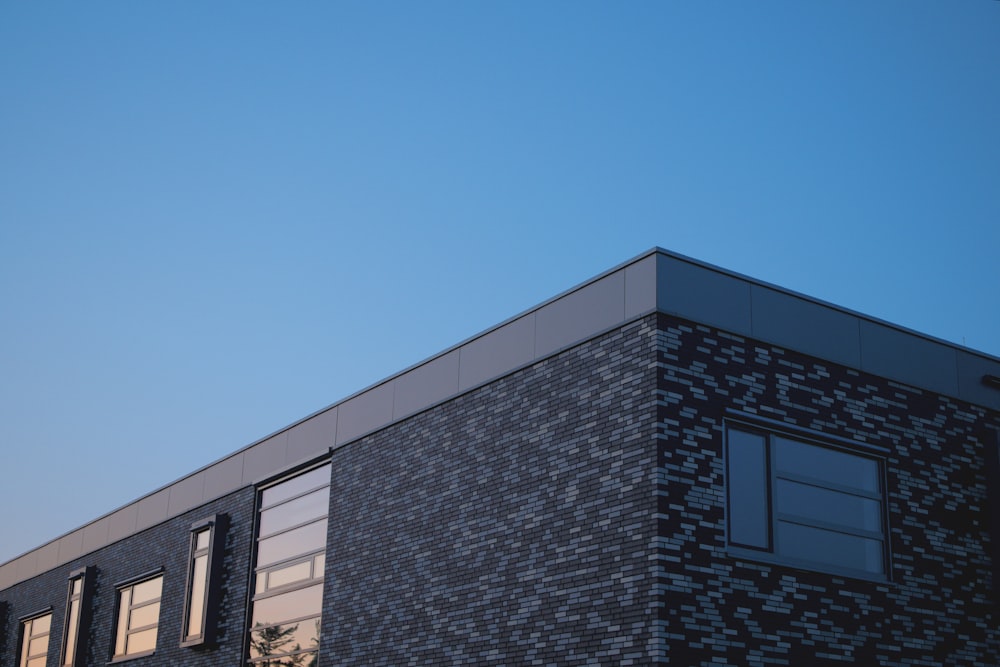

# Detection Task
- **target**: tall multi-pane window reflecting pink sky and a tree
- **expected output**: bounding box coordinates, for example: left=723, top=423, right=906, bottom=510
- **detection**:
left=248, top=464, right=331, bottom=667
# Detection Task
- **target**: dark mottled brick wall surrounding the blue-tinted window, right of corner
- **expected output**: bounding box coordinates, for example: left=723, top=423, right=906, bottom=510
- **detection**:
left=656, top=316, right=1000, bottom=667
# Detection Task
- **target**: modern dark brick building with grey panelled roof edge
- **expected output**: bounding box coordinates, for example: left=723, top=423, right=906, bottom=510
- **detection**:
left=0, top=249, right=1000, bottom=667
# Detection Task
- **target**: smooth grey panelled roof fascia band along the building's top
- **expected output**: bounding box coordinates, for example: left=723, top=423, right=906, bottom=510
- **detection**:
left=0, top=247, right=1000, bottom=590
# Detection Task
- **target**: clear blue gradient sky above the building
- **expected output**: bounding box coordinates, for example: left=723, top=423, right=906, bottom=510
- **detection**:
left=0, top=0, right=1000, bottom=562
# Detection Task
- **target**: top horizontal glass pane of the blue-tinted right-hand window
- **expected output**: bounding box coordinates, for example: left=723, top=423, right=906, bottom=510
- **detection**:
left=774, top=437, right=879, bottom=492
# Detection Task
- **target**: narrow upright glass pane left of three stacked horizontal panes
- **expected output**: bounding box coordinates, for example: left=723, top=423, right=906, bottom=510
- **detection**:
left=726, top=430, right=769, bottom=549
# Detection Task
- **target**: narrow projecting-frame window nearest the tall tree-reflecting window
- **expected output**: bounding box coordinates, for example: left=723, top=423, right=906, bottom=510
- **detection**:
left=181, top=515, right=225, bottom=646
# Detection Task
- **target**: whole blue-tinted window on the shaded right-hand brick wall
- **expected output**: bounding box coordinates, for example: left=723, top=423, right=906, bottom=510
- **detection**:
left=726, top=424, right=887, bottom=578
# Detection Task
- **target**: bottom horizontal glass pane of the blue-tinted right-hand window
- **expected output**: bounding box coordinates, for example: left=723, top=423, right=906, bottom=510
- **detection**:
left=777, top=521, right=884, bottom=574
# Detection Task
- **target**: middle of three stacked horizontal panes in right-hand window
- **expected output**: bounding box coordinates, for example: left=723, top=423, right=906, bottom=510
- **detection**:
left=777, top=479, right=882, bottom=532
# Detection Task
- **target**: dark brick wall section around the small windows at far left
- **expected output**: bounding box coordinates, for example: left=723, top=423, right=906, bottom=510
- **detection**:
left=0, top=489, right=254, bottom=667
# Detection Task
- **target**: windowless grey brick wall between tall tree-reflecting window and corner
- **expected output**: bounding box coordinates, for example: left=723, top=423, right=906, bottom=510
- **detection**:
left=322, top=318, right=656, bottom=666
